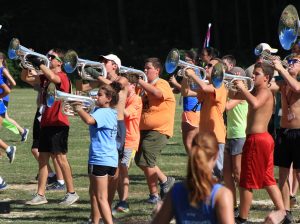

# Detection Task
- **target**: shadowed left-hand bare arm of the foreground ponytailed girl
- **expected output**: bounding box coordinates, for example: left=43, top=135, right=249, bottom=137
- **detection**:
left=151, top=190, right=173, bottom=224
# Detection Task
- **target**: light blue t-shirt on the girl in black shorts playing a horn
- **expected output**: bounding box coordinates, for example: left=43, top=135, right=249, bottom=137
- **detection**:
left=88, top=108, right=118, bottom=167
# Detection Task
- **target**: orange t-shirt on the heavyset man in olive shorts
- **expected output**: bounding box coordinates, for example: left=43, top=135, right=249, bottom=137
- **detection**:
left=140, top=79, right=176, bottom=137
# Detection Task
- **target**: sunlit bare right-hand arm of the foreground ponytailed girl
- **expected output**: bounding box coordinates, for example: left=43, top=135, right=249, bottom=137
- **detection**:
left=215, top=187, right=234, bottom=224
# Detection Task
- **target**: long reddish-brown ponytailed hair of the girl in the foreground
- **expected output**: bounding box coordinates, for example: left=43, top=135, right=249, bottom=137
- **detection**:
left=187, top=132, right=219, bottom=207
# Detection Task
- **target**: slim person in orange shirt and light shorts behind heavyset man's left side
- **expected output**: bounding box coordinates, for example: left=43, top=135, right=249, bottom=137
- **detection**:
left=112, top=73, right=143, bottom=215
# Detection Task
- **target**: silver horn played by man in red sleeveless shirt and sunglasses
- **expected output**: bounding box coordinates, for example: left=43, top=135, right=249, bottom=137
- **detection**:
left=8, top=38, right=50, bottom=73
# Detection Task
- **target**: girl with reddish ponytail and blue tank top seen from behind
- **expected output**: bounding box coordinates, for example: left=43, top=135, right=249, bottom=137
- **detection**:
left=152, top=133, right=234, bottom=224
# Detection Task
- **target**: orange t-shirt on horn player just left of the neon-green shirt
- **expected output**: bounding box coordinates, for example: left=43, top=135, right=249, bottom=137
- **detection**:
left=198, top=84, right=227, bottom=144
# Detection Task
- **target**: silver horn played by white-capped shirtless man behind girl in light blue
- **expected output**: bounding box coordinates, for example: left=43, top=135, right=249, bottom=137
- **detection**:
left=64, top=50, right=107, bottom=81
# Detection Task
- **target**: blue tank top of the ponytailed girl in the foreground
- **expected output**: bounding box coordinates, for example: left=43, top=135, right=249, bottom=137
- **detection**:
left=172, top=182, right=222, bottom=224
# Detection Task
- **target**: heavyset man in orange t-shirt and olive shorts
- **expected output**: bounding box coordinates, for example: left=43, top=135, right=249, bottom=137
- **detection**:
left=135, top=58, right=176, bottom=204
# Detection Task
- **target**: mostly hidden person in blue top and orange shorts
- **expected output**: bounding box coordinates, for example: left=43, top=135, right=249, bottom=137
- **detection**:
left=169, top=50, right=201, bottom=153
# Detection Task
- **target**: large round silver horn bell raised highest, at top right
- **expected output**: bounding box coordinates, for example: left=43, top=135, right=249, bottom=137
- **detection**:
left=278, top=5, right=300, bottom=50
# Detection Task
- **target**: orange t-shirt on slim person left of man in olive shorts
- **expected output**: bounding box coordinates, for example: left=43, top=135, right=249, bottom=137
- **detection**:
left=124, top=94, right=143, bottom=150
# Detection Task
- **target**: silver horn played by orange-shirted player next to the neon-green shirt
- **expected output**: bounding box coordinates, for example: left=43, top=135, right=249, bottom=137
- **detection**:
left=165, top=48, right=206, bottom=80
